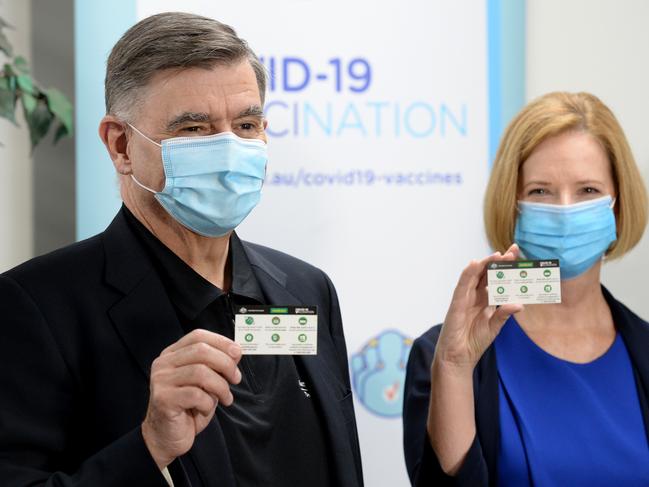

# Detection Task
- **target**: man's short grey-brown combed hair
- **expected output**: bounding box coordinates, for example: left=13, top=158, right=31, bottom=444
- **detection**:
left=105, top=12, right=266, bottom=119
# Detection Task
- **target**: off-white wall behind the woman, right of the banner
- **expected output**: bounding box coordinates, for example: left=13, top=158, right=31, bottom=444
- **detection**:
left=527, top=0, right=649, bottom=319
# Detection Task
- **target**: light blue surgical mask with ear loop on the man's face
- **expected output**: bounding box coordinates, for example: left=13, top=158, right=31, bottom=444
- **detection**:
left=129, top=124, right=268, bottom=237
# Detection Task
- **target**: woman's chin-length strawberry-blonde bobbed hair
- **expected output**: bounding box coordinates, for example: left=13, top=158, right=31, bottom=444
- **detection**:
left=484, top=92, right=647, bottom=259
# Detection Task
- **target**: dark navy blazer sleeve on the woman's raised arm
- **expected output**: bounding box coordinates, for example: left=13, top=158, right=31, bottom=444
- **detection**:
left=403, top=325, right=489, bottom=487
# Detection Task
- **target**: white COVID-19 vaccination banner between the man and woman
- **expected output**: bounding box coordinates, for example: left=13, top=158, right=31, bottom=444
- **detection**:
left=80, top=0, right=523, bottom=487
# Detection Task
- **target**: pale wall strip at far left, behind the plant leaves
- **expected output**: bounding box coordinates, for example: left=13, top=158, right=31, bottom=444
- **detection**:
left=0, top=0, right=34, bottom=272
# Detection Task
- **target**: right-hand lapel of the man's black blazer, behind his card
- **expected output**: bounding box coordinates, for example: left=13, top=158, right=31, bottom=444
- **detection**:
left=244, top=244, right=359, bottom=487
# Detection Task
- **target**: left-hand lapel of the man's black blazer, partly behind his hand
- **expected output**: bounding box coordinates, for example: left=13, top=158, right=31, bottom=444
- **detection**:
left=104, top=213, right=235, bottom=487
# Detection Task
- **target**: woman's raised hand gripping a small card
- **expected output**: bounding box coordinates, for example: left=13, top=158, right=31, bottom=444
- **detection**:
left=435, top=244, right=523, bottom=372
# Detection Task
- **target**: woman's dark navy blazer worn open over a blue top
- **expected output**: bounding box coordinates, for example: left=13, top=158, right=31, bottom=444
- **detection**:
left=403, top=287, right=649, bottom=487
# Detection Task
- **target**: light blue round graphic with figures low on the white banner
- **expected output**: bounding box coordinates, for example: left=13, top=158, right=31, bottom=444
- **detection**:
left=351, top=330, right=412, bottom=418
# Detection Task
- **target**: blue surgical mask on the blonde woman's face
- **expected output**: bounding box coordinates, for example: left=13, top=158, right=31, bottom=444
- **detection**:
left=514, top=196, right=617, bottom=279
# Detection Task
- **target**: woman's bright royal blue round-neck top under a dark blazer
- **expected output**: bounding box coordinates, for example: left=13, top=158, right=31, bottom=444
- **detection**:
left=495, top=317, right=649, bottom=487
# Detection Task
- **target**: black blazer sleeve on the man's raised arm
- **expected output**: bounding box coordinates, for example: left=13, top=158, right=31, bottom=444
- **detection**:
left=0, top=275, right=167, bottom=487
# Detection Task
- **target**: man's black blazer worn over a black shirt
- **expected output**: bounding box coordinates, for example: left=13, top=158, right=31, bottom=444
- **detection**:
left=0, top=213, right=363, bottom=487
